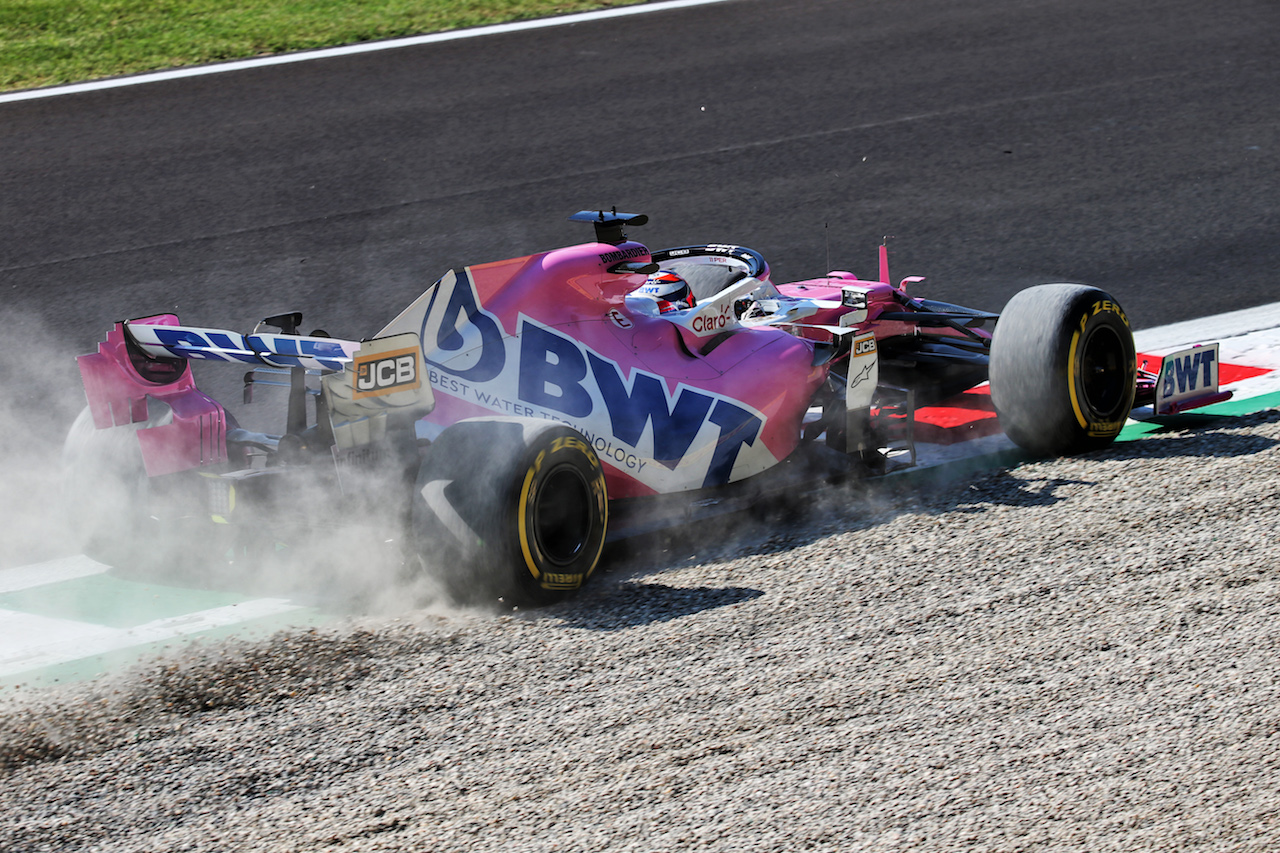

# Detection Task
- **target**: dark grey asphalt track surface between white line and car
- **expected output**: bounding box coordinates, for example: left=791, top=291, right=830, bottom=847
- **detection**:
left=0, top=0, right=1280, bottom=358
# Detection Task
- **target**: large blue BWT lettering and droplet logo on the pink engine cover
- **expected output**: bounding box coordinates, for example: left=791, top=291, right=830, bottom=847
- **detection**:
left=422, top=267, right=764, bottom=485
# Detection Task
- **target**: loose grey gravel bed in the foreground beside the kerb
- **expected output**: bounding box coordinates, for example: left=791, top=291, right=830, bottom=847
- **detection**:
left=0, top=411, right=1280, bottom=852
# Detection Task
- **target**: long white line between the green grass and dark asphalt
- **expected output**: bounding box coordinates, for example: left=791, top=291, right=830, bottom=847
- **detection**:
left=0, top=0, right=731, bottom=104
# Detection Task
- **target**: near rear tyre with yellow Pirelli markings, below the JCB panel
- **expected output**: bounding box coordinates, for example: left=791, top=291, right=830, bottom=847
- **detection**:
left=413, top=418, right=608, bottom=605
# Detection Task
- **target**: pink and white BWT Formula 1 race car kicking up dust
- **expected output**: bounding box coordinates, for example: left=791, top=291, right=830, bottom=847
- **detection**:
left=67, top=210, right=1222, bottom=602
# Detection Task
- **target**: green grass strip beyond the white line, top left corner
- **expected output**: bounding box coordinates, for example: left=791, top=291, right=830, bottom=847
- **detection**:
left=0, top=0, right=640, bottom=91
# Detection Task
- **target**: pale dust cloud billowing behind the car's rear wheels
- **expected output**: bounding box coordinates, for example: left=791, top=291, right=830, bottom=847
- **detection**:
left=0, top=311, right=465, bottom=635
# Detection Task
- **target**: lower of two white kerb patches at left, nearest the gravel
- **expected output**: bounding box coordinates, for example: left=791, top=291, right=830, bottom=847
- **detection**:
left=0, top=598, right=301, bottom=678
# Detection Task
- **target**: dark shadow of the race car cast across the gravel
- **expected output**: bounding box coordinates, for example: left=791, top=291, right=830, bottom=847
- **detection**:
left=563, top=410, right=1280, bottom=617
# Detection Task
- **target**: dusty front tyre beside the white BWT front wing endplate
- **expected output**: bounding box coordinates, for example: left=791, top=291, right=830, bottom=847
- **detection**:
left=991, top=284, right=1137, bottom=456
